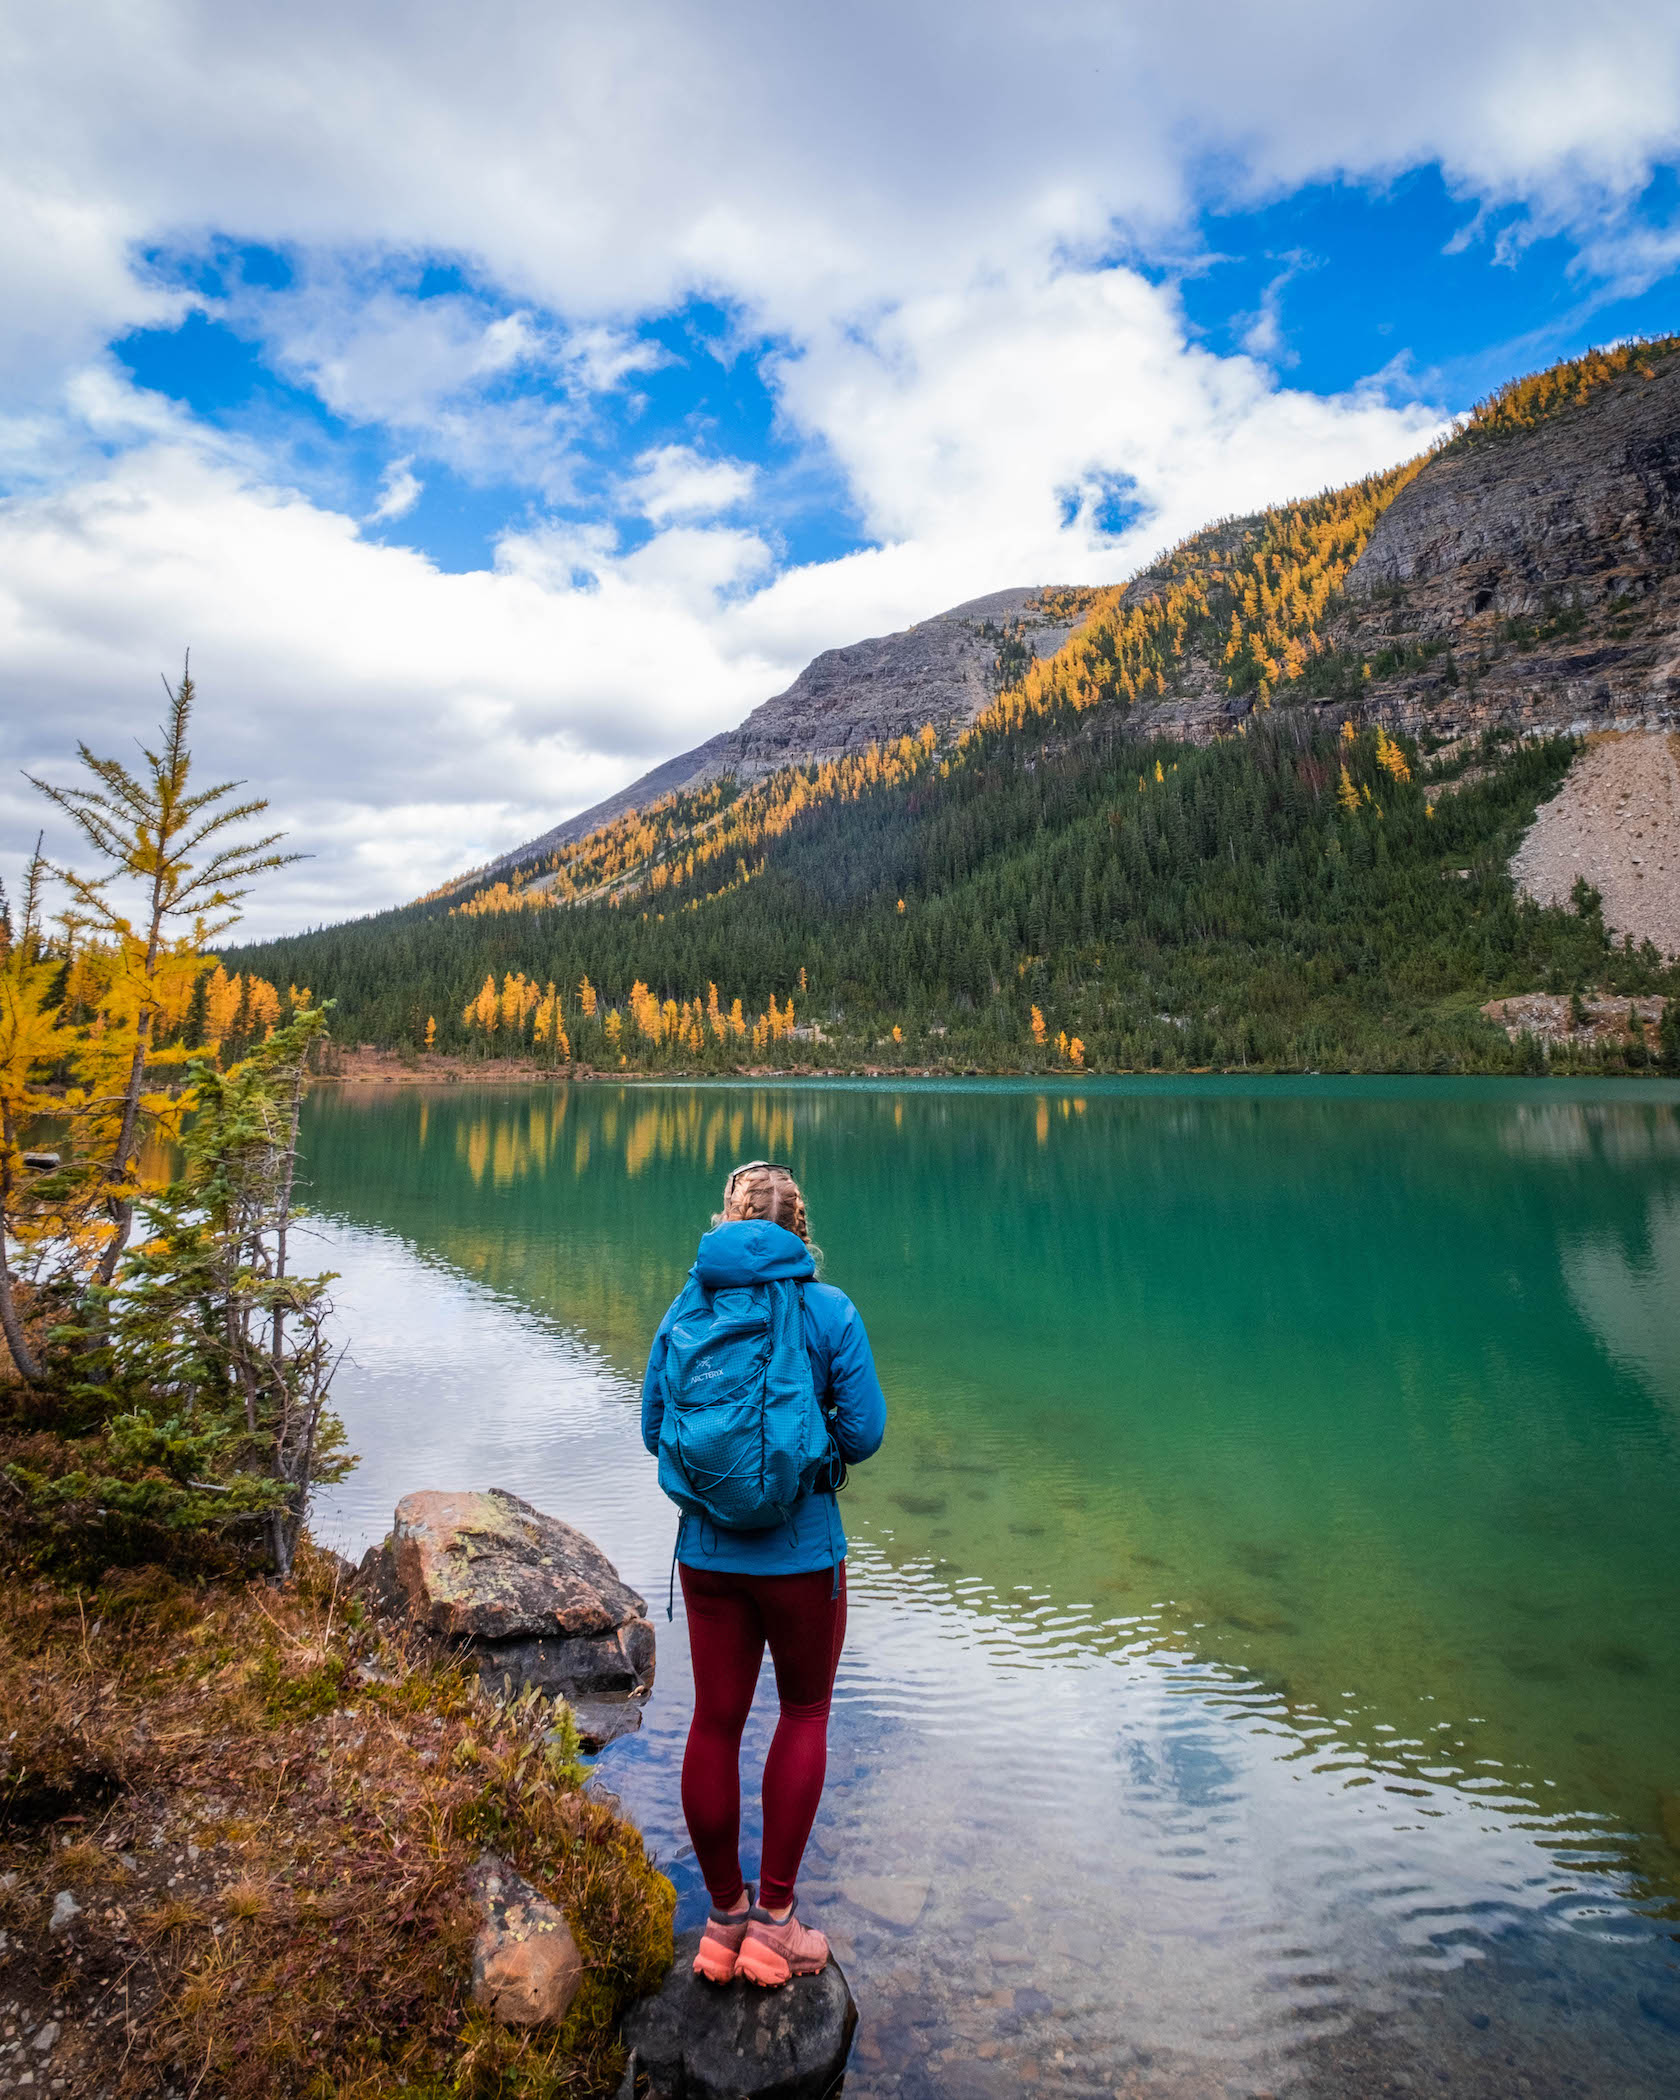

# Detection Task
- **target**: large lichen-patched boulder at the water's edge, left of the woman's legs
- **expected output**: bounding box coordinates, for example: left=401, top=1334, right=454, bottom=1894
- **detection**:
left=355, top=1487, right=653, bottom=1747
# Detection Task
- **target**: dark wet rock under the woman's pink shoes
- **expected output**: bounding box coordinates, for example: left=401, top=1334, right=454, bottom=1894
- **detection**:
left=624, top=1932, right=857, bottom=2100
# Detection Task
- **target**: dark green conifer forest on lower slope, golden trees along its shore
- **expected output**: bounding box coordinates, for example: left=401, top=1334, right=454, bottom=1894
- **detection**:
left=227, top=708, right=1680, bottom=1071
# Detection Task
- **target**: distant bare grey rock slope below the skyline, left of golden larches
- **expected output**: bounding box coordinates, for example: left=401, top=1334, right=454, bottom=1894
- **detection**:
left=489, top=588, right=1090, bottom=874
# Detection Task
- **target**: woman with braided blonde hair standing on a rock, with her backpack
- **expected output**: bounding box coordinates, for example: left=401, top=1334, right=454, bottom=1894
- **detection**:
left=643, top=1159, right=886, bottom=1985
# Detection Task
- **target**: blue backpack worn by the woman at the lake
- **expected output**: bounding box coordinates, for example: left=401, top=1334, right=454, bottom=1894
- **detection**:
left=659, top=1277, right=838, bottom=1531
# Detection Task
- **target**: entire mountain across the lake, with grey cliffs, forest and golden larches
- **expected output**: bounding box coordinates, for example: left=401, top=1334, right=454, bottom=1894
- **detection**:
left=227, top=338, right=1680, bottom=1073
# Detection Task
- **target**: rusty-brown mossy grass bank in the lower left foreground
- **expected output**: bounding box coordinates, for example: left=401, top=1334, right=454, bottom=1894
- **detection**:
left=0, top=1552, right=674, bottom=2100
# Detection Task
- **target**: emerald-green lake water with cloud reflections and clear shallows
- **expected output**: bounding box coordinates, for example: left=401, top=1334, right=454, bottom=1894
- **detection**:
left=307, top=1082, right=1680, bottom=2096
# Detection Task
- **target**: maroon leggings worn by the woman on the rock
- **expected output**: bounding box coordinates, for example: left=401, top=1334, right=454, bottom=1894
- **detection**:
left=683, top=1562, right=846, bottom=1911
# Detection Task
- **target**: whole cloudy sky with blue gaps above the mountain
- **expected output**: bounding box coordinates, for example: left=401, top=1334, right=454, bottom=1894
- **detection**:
left=0, top=0, right=1680, bottom=924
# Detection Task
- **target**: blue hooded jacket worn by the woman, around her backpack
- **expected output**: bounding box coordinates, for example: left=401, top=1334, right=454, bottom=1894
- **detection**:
left=643, top=1218, right=886, bottom=1575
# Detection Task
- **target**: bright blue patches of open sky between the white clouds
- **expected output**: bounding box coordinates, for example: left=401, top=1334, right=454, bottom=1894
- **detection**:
left=109, top=166, right=1680, bottom=571
